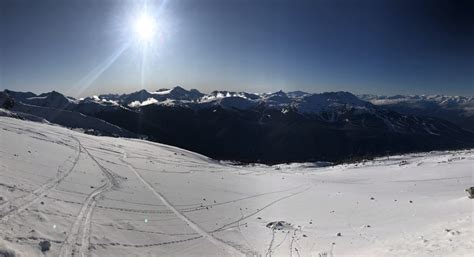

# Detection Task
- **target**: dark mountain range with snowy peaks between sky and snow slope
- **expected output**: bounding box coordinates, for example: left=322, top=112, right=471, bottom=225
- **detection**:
left=0, top=87, right=474, bottom=163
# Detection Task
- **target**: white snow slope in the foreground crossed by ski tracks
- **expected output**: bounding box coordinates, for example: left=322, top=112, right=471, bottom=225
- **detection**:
left=0, top=117, right=474, bottom=257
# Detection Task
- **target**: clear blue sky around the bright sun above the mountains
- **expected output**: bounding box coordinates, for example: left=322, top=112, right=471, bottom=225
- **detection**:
left=0, top=0, right=474, bottom=97
